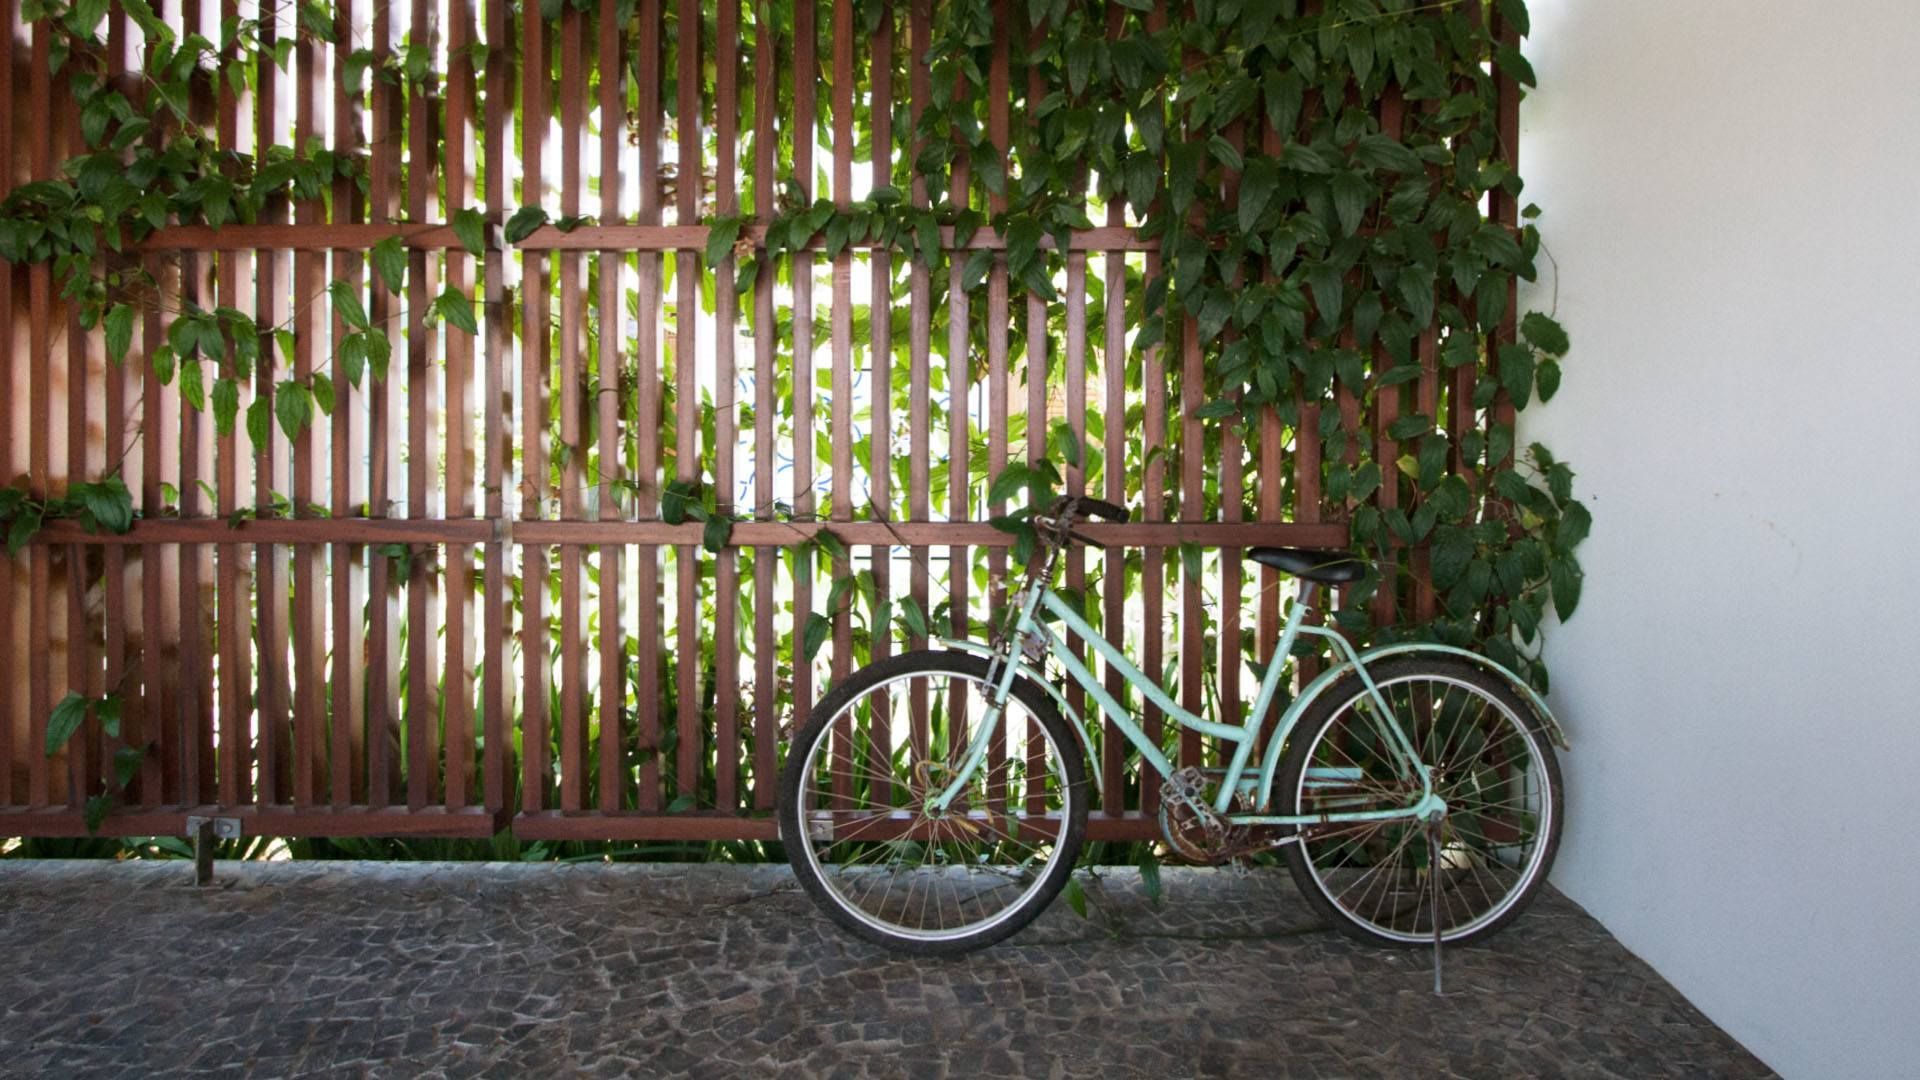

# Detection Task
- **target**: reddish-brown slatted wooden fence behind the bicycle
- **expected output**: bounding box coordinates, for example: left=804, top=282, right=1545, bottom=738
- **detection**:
left=0, top=0, right=1519, bottom=840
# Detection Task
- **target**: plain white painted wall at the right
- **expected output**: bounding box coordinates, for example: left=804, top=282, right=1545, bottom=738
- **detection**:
left=1521, top=0, right=1920, bottom=1078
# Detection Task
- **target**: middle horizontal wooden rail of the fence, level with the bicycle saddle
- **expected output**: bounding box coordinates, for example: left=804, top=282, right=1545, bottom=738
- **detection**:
left=33, top=517, right=1348, bottom=548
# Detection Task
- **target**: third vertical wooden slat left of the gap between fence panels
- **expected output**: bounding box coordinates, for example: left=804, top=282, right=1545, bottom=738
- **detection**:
left=405, top=0, right=439, bottom=811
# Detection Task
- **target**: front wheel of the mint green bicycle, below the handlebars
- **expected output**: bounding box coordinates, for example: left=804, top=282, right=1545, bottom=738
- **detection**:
left=780, top=651, right=1089, bottom=955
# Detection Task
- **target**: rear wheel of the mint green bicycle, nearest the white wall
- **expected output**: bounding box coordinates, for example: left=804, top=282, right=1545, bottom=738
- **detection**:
left=1281, top=645, right=1561, bottom=945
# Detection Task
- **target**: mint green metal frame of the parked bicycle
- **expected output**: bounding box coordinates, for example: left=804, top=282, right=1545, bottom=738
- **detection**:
left=933, top=580, right=1446, bottom=824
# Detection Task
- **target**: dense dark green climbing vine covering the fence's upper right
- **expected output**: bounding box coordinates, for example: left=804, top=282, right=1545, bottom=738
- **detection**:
left=725, top=0, right=1592, bottom=686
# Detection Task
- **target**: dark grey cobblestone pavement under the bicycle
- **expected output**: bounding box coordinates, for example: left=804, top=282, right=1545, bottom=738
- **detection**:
left=0, top=861, right=1768, bottom=1078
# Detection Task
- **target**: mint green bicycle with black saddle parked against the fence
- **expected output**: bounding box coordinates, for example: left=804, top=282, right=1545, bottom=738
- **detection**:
left=780, top=496, right=1565, bottom=953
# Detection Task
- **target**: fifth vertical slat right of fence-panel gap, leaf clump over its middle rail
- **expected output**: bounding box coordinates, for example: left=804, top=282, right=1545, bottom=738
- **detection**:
left=674, top=0, right=707, bottom=798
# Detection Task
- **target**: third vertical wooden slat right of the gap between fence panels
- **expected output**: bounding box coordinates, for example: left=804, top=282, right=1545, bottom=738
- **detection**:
left=597, top=2, right=626, bottom=813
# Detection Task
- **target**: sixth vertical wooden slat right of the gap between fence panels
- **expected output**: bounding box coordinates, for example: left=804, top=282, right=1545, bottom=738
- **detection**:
left=708, top=0, right=739, bottom=811
